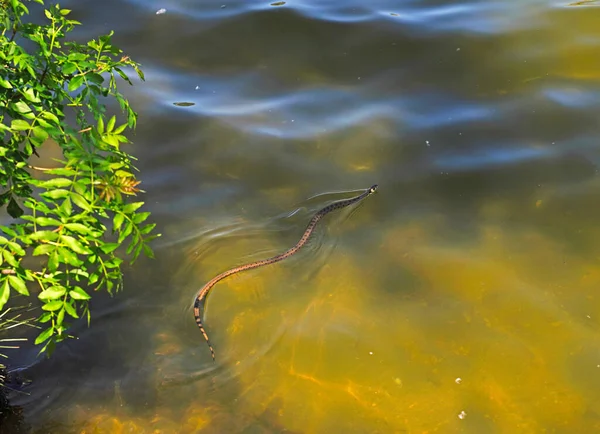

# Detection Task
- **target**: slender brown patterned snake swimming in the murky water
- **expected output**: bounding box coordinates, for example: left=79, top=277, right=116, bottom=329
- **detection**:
left=194, top=184, right=377, bottom=362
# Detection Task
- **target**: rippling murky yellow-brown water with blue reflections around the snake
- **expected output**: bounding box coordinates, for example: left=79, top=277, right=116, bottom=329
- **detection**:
left=3, top=0, right=600, bottom=434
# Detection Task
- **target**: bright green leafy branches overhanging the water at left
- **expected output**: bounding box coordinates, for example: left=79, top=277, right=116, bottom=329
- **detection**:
left=0, top=0, right=158, bottom=352
